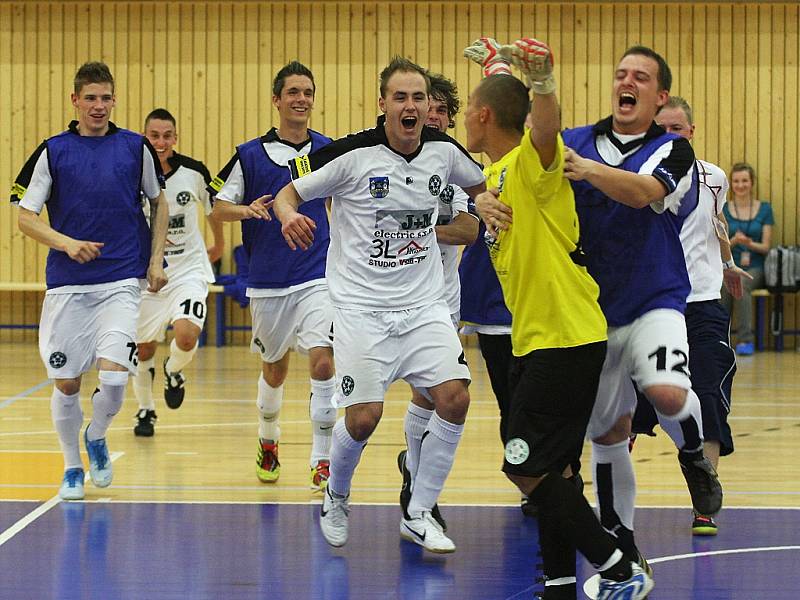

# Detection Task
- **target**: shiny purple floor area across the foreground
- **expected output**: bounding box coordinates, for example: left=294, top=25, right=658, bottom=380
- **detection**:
left=0, top=502, right=800, bottom=600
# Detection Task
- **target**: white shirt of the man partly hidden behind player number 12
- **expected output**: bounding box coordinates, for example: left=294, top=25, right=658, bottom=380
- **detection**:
left=681, top=160, right=728, bottom=302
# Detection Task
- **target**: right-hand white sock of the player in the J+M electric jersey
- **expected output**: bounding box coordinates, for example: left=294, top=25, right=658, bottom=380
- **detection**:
left=408, top=412, right=464, bottom=519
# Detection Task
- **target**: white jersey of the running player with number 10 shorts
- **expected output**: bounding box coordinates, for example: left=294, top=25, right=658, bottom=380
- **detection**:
left=145, top=153, right=214, bottom=287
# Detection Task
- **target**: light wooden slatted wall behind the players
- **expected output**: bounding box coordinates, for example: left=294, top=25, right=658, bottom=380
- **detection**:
left=0, top=0, right=800, bottom=342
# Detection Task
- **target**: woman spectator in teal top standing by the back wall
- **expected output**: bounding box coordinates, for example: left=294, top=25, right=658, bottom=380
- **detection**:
left=722, top=162, right=775, bottom=356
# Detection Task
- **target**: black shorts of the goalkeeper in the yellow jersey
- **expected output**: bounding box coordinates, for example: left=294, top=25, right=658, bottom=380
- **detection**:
left=503, top=342, right=606, bottom=477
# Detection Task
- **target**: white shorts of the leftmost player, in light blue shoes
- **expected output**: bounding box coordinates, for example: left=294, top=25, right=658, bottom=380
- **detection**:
left=39, top=285, right=141, bottom=379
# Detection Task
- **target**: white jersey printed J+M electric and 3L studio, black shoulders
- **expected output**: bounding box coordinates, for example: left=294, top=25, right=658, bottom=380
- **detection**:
left=289, top=126, right=484, bottom=311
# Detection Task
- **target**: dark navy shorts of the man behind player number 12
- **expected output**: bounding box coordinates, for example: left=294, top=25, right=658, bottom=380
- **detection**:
left=633, top=300, right=736, bottom=456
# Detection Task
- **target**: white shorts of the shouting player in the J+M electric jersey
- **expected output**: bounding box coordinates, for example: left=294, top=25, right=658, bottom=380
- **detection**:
left=333, top=301, right=470, bottom=408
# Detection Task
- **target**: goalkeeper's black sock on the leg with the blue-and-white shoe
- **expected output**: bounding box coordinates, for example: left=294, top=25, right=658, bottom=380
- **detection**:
left=530, top=474, right=617, bottom=568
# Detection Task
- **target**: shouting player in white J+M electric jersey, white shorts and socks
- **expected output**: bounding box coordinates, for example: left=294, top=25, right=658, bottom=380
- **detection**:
left=272, top=58, right=485, bottom=553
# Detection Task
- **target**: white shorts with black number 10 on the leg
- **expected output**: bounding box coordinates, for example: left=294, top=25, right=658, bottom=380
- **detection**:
left=136, top=279, right=208, bottom=344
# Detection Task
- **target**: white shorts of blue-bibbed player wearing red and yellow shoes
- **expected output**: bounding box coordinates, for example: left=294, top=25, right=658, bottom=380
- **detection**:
left=250, top=285, right=333, bottom=363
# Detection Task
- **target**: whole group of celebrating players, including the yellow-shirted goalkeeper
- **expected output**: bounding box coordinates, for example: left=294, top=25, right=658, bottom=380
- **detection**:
left=12, top=38, right=746, bottom=600
